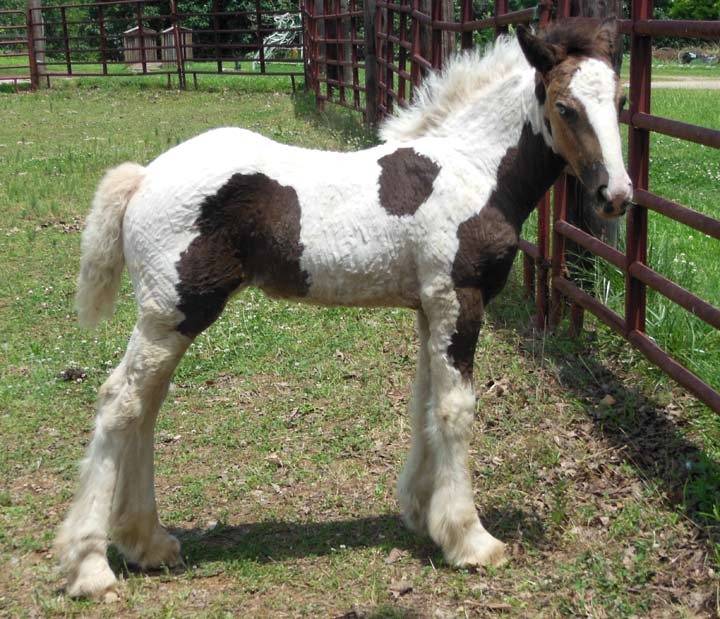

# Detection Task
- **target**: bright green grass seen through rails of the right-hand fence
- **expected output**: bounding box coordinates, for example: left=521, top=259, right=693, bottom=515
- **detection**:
left=524, top=89, right=720, bottom=406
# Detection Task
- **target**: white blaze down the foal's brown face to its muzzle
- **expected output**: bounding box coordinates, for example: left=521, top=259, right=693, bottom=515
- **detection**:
left=570, top=58, right=632, bottom=205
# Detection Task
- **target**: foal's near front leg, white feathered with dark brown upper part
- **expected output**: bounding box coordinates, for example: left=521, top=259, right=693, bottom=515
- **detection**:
left=426, top=289, right=505, bottom=566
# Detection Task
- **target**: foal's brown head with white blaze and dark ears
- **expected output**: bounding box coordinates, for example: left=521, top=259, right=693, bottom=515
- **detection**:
left=518, top=19, right=632, bottom=217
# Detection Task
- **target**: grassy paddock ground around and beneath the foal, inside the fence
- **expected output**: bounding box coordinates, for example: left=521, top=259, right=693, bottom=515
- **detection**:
left=0, top=78, right=720, bottom=617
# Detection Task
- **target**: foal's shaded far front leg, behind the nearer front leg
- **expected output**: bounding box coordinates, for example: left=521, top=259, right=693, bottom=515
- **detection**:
left=397, top=310, right=433, bottom=533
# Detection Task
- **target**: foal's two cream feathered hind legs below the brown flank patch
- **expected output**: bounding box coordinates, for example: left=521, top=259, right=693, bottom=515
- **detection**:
left=55, top=317, right=190, bottom=596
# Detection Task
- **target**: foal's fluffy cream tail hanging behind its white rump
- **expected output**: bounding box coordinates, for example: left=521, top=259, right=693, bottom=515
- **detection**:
left=75, top=163, right=145, bottom=327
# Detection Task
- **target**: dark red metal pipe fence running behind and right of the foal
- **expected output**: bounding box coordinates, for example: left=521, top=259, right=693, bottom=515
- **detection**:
left=305, top=0, right=720, bottom=413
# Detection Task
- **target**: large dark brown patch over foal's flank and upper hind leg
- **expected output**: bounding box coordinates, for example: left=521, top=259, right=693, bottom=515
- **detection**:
left=176, top=174, right=309, bottom=337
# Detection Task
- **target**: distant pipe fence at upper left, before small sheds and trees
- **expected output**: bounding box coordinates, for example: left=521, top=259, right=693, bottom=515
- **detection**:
left=0, top=0, right=305, bottom=88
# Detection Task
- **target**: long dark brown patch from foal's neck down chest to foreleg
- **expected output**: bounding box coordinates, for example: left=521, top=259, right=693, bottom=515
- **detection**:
left=448, top=124, right=565, bottom=380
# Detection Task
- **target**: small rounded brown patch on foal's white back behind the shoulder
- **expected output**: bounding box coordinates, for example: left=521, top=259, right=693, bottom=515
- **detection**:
left=378, top=148, right=440, bottom=217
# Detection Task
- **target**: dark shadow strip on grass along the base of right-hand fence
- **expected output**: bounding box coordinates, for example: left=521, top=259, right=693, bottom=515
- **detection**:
left=488, top=282, right=720, bottom=548
